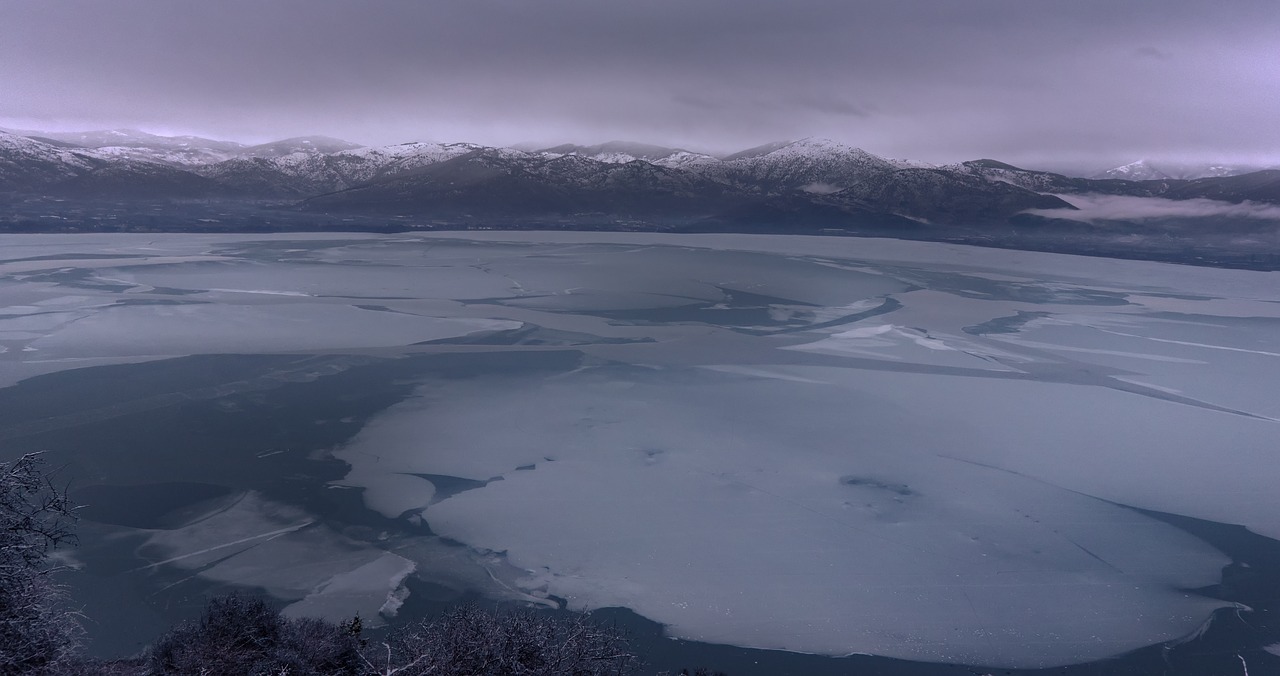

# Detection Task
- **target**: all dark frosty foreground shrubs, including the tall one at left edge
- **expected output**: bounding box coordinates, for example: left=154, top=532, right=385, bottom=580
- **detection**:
left=0, top=455, right=712, bottom=676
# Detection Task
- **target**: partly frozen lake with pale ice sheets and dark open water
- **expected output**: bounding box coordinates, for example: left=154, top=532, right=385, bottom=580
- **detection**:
left=0, top=233, right=1280, bottom=667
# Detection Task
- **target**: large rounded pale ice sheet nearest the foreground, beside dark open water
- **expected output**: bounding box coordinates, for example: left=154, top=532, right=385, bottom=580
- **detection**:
left=350, top=366, right=1225, bottom=666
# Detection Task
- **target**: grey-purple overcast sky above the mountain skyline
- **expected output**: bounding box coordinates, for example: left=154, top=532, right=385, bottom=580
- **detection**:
left=0, top=0, right=1280, bottom=174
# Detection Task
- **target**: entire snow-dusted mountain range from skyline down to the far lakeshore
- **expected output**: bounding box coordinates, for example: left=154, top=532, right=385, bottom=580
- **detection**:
left=0, top=132, right=1280, bottom=270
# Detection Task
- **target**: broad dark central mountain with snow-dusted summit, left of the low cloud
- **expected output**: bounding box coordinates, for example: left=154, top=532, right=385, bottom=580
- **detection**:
left=296, top=140, right=1071, bottom=225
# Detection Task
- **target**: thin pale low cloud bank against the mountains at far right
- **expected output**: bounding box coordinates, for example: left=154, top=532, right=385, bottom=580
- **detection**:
left=1025, top=193, right=1280, bottom=223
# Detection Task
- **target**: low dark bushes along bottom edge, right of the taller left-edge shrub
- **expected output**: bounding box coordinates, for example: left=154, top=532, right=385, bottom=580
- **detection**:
left=148, top=595, right=637, bottom=676
